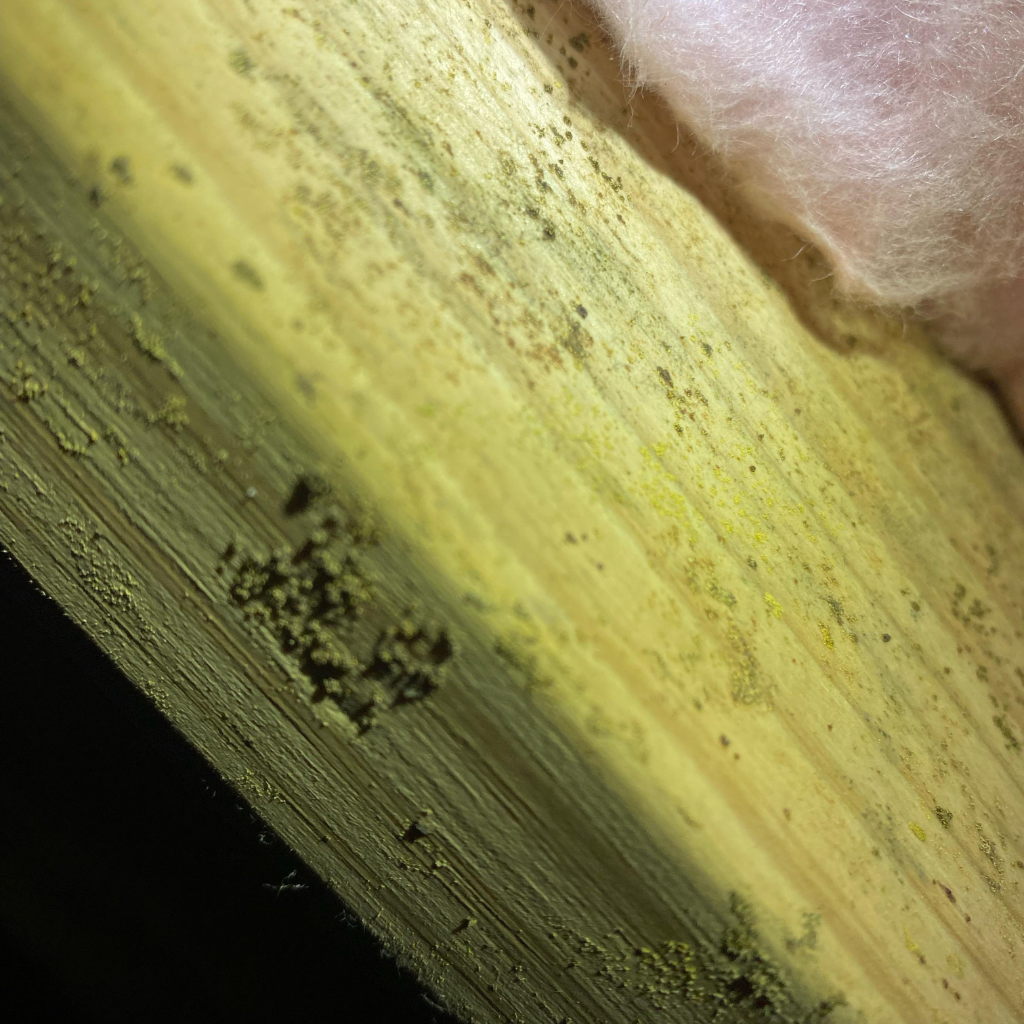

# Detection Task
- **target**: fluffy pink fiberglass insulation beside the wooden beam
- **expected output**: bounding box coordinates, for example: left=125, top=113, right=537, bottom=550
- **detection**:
left=593, top=0, right=1024, bottom=422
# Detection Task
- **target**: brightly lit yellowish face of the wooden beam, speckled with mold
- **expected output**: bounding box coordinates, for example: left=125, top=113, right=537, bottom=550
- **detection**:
left=0, top=0, right=1024, bottom=1024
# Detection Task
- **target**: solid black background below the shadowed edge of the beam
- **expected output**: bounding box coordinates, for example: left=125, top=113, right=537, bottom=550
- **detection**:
left=0, top=551, right=454, bottom=1024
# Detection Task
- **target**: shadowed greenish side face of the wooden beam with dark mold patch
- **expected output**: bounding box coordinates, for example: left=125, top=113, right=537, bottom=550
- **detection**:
left=0, top=108, right=839, bottom=1021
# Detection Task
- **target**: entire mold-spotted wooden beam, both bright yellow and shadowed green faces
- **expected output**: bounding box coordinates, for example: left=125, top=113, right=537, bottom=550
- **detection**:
left=0, top=0, right=1024, bottom=1024
